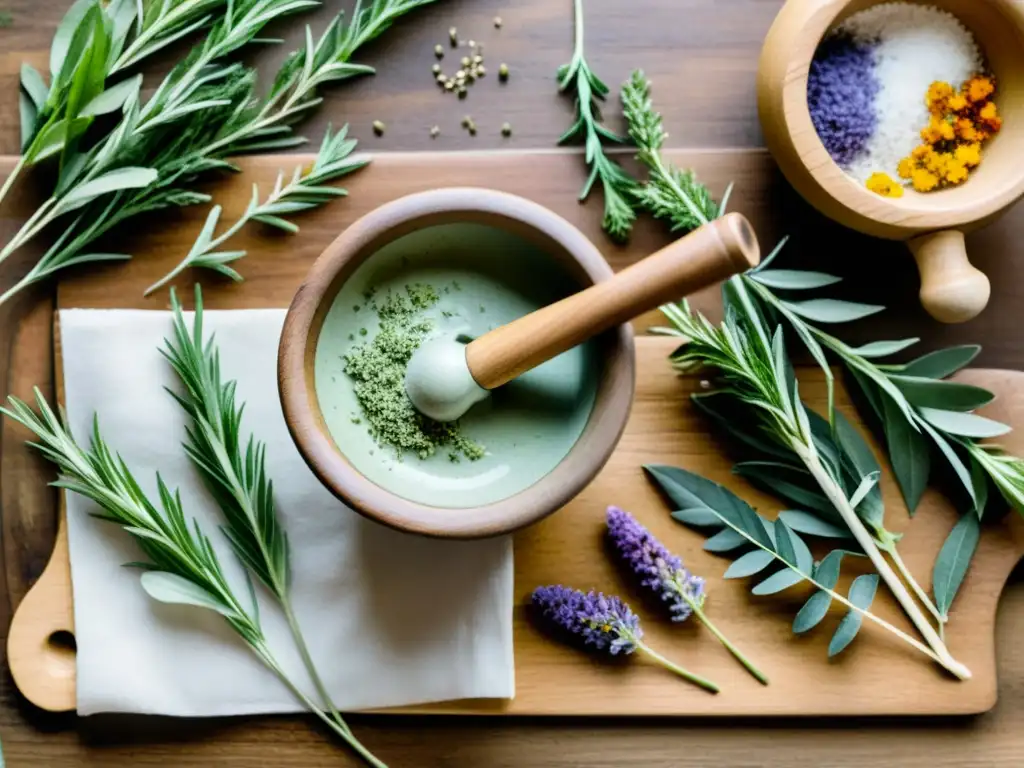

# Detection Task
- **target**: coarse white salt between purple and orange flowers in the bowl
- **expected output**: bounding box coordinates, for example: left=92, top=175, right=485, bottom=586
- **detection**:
left=836, top=2, right=984, bottom=183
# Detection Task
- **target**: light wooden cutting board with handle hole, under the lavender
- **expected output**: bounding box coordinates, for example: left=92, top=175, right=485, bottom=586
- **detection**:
left=8, top=337, right=1024, bottom=717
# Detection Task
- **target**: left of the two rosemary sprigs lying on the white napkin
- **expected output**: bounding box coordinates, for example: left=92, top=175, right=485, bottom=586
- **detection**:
left=0, top=389, right=386, bottom=768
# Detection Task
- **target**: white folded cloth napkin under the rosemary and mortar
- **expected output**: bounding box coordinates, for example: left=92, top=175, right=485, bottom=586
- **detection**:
left=59, top=309, right=514, bottom=716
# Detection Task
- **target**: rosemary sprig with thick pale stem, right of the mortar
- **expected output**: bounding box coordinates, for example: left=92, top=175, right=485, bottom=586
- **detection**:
left=664, top=296, right=971, bottom=679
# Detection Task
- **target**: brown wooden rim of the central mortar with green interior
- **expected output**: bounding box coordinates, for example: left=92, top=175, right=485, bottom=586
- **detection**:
left=278, top=188, right=636, bottom=539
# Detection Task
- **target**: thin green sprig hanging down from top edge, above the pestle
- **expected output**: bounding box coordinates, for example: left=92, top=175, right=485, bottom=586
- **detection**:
left=558, top=0, right=636, bottom=241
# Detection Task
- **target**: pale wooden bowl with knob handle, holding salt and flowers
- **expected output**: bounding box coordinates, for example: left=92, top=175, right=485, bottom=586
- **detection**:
left=758, top=0, right=1024, bottom=323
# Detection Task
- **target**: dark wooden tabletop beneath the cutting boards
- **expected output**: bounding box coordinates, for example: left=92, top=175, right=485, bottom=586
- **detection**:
left=0, top=0, right=1024, bottom=768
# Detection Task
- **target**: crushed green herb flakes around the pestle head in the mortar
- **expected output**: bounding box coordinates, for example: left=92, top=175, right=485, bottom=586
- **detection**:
left=344, top=283, right=484, bottom=461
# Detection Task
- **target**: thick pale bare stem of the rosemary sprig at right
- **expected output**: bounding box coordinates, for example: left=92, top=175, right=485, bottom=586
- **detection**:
left=791, top=440, right=971, bottom=680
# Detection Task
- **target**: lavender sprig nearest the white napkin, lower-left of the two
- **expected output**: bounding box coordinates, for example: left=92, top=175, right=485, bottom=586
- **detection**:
left=532, top=585, right=719, bottom=693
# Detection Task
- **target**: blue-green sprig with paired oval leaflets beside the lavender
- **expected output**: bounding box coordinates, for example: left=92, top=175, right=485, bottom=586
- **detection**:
left=644, top=465, right=879, bottom=655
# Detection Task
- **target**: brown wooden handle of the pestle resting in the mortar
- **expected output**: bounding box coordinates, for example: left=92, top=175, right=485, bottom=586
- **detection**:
left=466, top=213, right=760, bottom=389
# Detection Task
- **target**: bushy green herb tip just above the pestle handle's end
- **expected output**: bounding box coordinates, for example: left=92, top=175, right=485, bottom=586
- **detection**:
left=621, top=70, right=731, bottom=234
